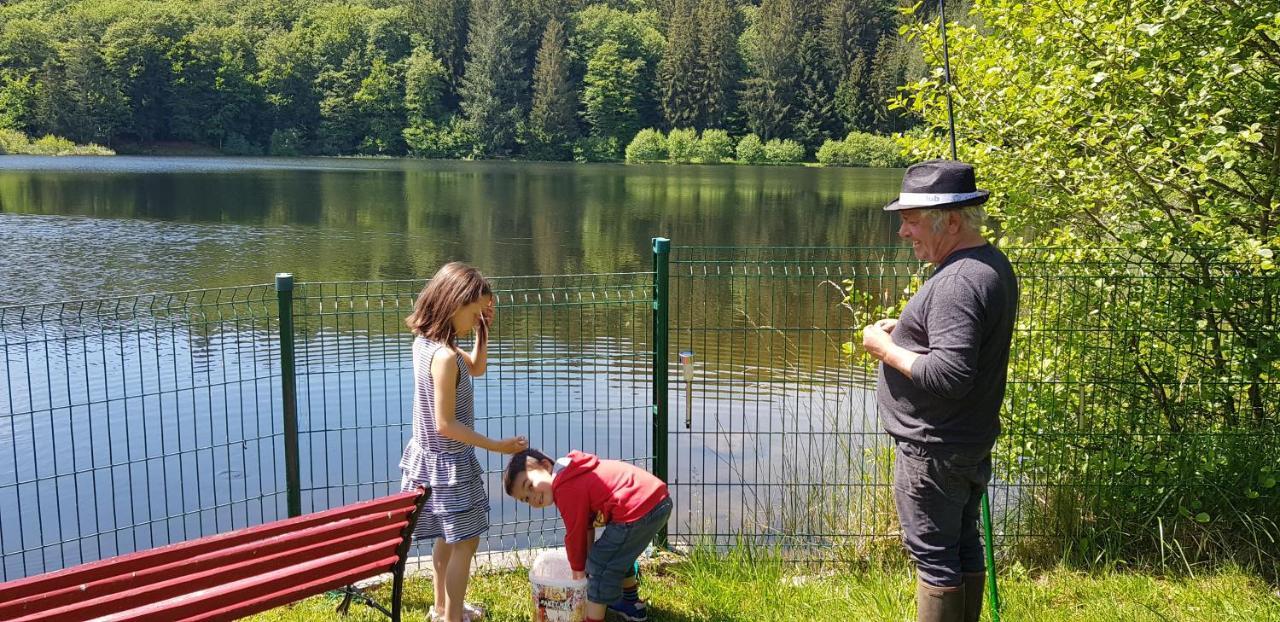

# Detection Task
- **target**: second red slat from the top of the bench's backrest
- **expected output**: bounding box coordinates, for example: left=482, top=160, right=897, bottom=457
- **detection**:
left=0, top=516, right=408, bottom=619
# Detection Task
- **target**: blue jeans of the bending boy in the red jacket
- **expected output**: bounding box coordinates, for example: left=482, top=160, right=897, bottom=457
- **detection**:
left=586, top=497, right=671, bottom=604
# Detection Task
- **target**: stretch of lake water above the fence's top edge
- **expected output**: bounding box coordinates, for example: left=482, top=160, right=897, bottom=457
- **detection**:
left=0, top=156, right=901, bottom=305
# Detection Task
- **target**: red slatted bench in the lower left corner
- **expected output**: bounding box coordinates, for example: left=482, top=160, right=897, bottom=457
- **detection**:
left=0, top=489, right=430, bottom=622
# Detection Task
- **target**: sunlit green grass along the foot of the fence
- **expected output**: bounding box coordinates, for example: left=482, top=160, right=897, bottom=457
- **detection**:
left=241, top=553, right=1280, bottom=622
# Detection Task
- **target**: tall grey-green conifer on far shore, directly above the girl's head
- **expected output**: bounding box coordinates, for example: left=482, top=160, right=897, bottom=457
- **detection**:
left=461, top=0, right=527, bottom=157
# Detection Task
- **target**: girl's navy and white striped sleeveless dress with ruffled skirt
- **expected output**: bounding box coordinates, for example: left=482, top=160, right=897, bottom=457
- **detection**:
left=401, top=337, right=489, bottom=544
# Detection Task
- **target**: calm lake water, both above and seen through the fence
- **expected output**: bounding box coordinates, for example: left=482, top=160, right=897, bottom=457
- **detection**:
left=0, top=156, right=901, bottom=578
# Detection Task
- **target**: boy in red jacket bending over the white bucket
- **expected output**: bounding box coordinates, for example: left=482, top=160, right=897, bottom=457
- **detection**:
left=502, top=449, right=671, bottom=622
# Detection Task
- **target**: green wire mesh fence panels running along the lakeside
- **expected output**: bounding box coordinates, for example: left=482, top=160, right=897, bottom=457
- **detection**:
left=0, top=241, right=1280, bottom=580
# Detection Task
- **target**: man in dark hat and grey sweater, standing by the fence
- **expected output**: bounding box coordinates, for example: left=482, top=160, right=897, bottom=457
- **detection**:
left=863, top=160, right=1018, bottom=622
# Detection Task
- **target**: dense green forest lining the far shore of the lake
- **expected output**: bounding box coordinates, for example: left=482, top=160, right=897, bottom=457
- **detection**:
left=0, top=0, right=942, bottom=160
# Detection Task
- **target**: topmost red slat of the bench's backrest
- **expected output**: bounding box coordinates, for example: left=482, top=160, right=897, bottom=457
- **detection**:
left=0, top=490, right=419, bottom=603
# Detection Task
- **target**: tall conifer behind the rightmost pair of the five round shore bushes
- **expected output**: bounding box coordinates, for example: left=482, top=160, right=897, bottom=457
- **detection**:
left=741, top=0, right=800, bottom=138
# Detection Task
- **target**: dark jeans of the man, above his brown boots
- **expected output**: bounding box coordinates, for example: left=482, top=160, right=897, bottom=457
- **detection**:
left=893, top=440, right=991, bottom=587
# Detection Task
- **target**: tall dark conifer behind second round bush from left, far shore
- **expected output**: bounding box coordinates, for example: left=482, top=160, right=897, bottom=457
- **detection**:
left=658, top=0, right=704, bottom=128
